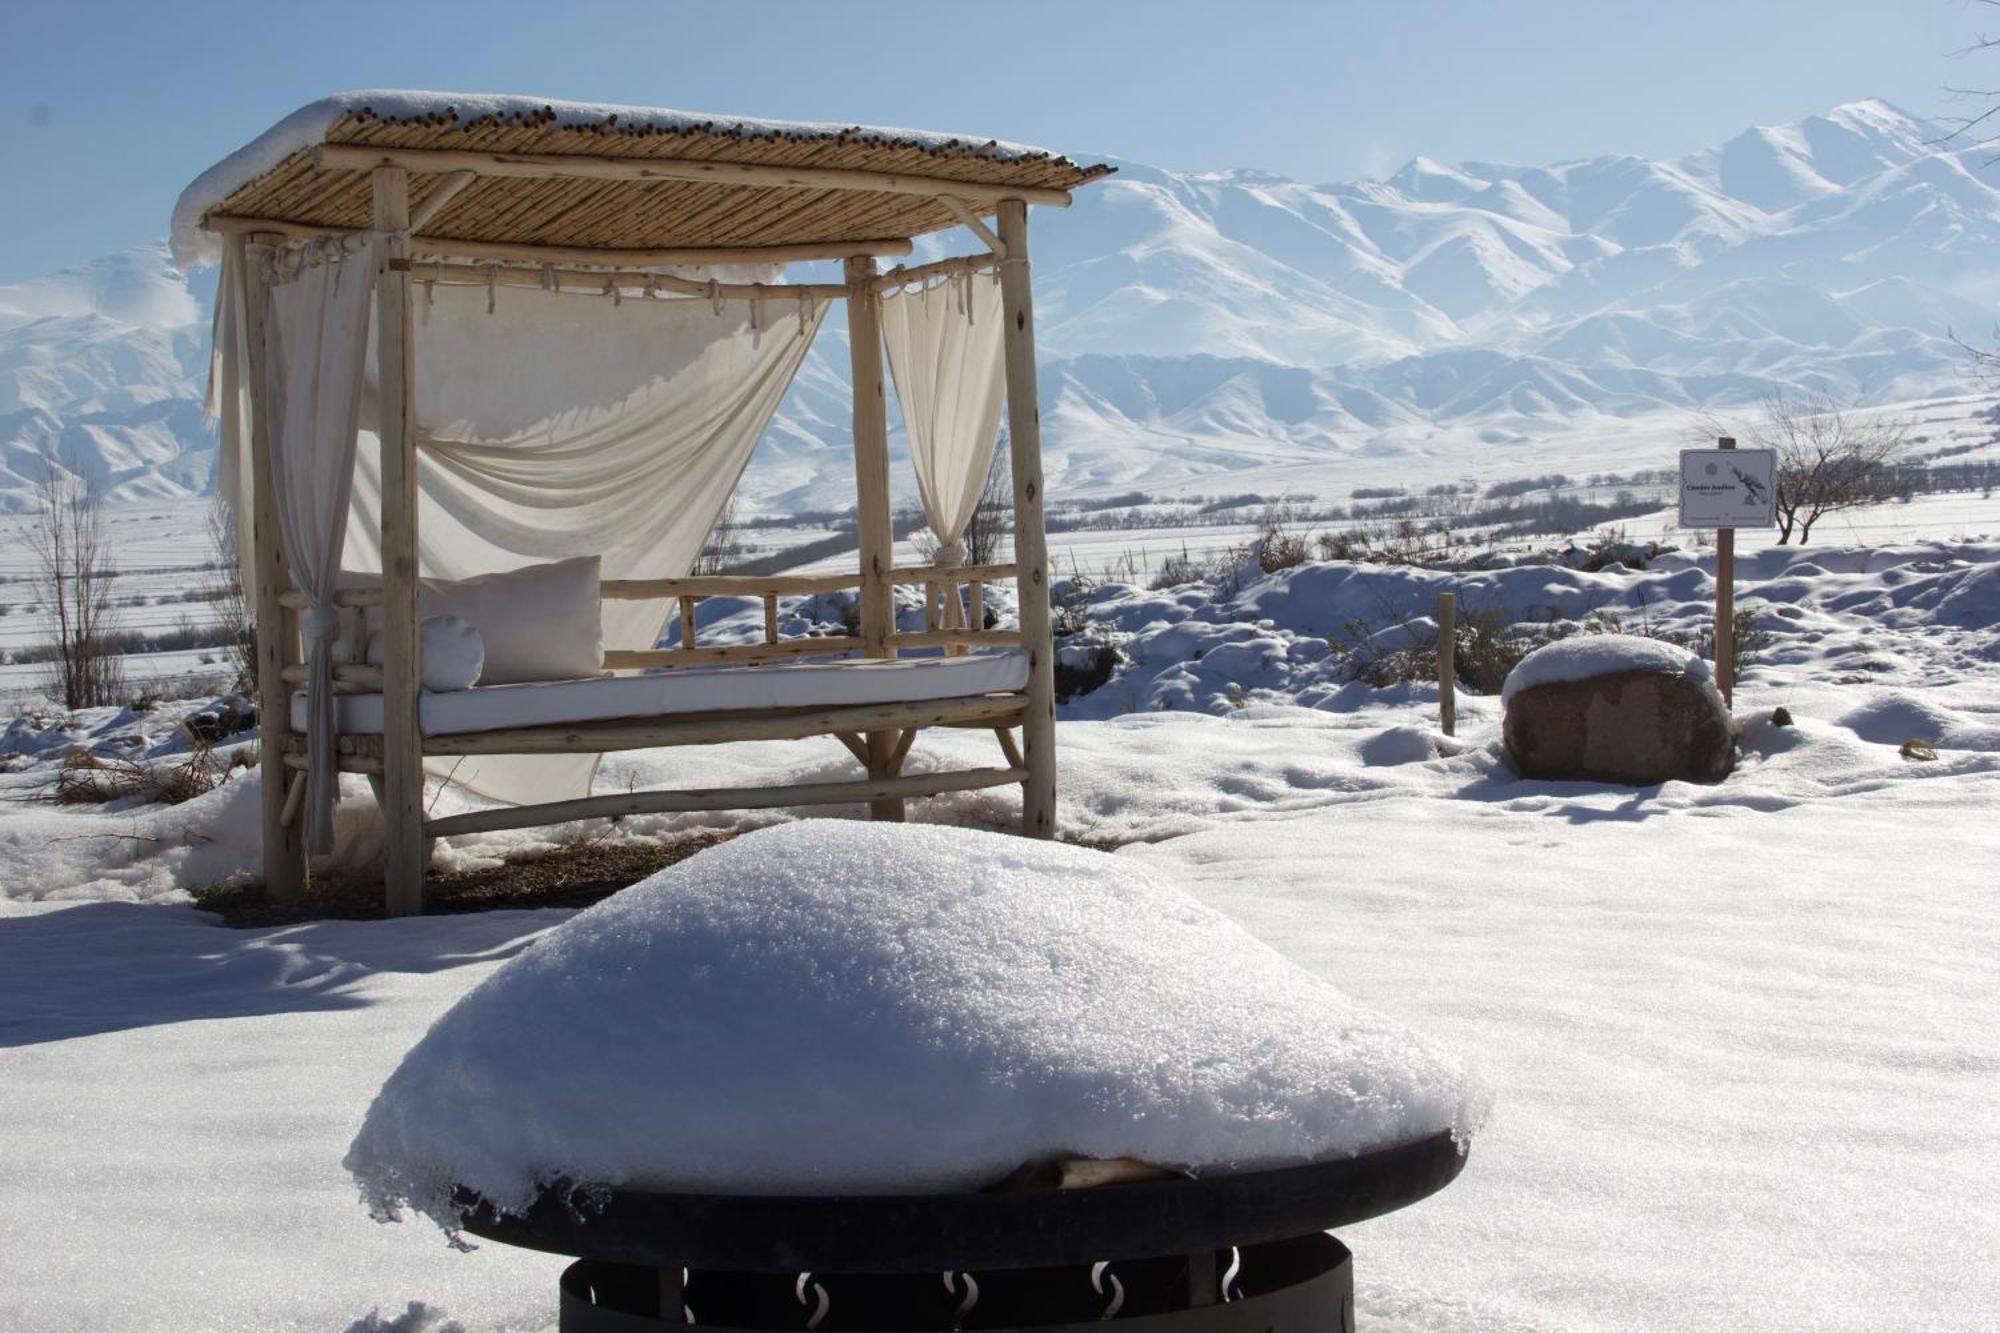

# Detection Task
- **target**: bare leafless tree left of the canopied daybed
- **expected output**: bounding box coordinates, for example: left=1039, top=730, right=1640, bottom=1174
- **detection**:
left=28, top=460, right=124, bottom=709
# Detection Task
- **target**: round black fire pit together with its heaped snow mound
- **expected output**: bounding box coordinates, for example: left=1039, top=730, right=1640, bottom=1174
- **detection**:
left=348, top=821, right=1484, bottom=1333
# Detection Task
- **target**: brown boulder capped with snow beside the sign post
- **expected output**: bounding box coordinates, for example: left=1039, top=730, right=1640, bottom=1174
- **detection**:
left=1500, top=634, right=1736, bottom=787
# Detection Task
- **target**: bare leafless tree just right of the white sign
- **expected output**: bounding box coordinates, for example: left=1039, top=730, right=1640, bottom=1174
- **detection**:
left=1746, top=392, right=1910, bottom=546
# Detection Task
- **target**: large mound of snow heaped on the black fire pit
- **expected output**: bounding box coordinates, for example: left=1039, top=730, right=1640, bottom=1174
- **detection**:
left=346, top=821, right=1484, bottom=1225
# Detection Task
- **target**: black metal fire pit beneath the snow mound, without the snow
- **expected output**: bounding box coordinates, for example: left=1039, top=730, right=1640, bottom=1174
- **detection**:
left=458, top=1133, right=1464, bottom=1333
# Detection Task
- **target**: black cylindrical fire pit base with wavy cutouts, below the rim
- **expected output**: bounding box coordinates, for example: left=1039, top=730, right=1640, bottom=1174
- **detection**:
left=560, top=1235, right=1354, bottom=1333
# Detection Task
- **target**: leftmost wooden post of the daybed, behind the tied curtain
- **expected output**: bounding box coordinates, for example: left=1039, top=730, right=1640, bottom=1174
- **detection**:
left=239, top=234, right=306, bottom=901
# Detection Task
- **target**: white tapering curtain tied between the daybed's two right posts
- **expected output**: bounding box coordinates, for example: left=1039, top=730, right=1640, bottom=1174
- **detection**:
left=882, top=274, right=1006, bottom=564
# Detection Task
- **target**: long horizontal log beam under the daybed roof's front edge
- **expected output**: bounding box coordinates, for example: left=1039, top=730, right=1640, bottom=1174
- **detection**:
left=312, top=144, right=1070, bottom=208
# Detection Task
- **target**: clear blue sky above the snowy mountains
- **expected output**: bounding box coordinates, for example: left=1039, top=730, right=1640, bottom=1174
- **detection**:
left=0, top=0, right=2000, bottom=282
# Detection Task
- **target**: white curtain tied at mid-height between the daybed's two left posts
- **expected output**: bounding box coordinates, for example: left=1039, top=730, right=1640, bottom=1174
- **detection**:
left=264, top=246, right=374, bottom=853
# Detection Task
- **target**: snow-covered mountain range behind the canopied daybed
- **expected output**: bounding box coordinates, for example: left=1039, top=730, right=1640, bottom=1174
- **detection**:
left=0, top=102, right=2000, bottom=506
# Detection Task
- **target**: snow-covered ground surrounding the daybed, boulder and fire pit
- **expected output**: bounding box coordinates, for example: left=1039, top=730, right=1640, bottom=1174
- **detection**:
left=0, top=542, right=2000, bottom=1333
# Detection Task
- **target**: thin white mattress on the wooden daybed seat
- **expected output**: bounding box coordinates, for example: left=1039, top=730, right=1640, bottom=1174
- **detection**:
left=292, top=648, right=1028, bottom=737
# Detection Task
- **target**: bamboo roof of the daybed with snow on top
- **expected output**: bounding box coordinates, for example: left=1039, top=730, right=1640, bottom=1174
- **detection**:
left=172, top=90, right=1114, bottom=266
